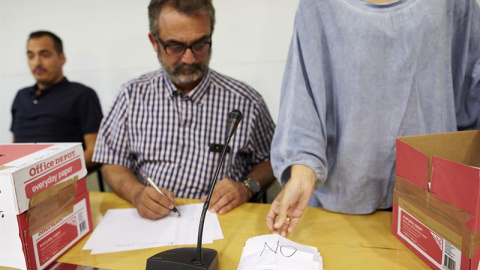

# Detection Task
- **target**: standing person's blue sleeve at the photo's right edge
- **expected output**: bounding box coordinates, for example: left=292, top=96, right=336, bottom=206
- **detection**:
left=452, top=0, right=480, bottom=130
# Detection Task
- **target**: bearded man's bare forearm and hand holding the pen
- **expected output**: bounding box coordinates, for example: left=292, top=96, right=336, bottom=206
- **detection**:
left=102, top=164, right=175, bottom=219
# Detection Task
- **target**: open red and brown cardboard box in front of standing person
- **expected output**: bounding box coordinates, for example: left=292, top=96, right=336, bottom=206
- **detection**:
left=392, top=131, right=480, bottom=270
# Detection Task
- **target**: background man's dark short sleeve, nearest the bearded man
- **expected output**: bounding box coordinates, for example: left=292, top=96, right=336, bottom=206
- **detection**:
left=77, top=88, right=103, bottom=135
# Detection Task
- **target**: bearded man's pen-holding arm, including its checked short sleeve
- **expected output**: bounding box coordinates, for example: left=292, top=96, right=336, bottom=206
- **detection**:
left=93, top=84, right=174, bottom=219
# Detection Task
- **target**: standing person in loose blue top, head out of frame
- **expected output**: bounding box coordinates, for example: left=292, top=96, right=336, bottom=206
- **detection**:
left=267, top=0, right=480, bottom=235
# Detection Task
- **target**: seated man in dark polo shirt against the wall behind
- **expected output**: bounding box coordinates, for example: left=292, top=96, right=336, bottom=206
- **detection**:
left=10, top=31, right=103, bottom=168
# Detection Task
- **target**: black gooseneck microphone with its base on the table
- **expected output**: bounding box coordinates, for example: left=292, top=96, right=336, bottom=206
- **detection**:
left=146, top=110, right=243, bottom=270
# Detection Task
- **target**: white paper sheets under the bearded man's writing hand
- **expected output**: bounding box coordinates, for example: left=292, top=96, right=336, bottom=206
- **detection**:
left=83, top=203, right=223, bottom=254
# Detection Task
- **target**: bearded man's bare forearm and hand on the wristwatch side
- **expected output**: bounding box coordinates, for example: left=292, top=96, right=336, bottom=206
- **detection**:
left=202, top=161, right=275, bottom=214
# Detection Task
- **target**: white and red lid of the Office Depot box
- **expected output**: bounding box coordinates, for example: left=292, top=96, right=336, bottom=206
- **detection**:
left=0, top=143, right=87, bottom=215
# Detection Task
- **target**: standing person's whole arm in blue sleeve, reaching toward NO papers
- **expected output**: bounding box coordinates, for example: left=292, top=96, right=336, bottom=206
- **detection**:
left=266, top=1, right=330, bottom=235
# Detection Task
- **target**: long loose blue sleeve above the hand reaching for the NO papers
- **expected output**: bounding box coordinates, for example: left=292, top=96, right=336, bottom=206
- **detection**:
left=271, top=1, right=331, bottom=188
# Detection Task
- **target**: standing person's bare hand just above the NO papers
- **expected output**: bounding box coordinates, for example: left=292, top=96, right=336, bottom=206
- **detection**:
left=267, top=165, right=315, bottom=237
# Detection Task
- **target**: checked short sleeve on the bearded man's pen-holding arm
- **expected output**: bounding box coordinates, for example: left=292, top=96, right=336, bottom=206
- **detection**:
left=93, top=88, right=132, bottom=168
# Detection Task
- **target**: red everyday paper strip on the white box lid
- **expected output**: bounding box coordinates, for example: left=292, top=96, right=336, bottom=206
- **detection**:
left=25, top=159, right=82, bottom=199
